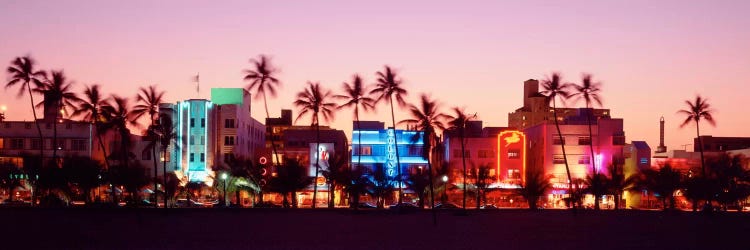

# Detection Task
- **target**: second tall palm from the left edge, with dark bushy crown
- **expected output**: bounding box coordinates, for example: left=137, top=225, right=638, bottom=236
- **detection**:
left=36, top=70, right=80, bottom=164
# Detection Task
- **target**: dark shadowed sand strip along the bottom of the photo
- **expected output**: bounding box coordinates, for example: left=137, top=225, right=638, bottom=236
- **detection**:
left=0, top=209, right=750, bottom=249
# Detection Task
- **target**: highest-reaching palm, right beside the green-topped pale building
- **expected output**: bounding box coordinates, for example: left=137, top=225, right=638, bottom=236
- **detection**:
left=243, top=55, right=281, bottom=173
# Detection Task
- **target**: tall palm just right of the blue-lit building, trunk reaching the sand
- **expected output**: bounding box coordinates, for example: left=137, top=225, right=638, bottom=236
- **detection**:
left=399, top=94, right=447, bottom=223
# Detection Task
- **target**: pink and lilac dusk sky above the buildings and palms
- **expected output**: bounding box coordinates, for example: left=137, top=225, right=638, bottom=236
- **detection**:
left=0, top=0, right=750, bottom=149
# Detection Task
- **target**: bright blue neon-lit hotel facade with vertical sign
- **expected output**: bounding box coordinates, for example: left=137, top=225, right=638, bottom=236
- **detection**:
left=351, top=121, right=427, bottom=177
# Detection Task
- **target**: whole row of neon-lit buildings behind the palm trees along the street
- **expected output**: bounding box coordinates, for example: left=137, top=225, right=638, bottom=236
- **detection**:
left=0, top=79, right=750, bottom=207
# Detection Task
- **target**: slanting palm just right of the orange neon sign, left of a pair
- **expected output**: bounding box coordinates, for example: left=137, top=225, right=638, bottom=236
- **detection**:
left=541, top=72, right=575, bottom=207
